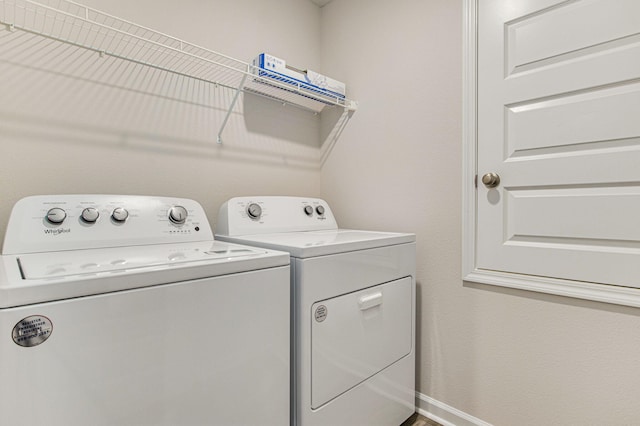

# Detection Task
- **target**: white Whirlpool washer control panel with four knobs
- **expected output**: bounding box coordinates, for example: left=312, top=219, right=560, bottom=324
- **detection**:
left=2, top=195, right=213, bottom=254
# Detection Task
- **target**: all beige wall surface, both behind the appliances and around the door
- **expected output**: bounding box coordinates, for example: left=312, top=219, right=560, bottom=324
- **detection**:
left=5, top=0, right=640, bottom=426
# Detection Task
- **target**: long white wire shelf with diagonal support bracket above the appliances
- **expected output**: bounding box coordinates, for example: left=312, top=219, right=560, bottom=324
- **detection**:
left=0, top=0, right=357, bottom=141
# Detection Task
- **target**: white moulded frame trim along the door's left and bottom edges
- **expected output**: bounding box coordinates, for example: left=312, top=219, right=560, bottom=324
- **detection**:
left=462, top=0, right=640, bottom=307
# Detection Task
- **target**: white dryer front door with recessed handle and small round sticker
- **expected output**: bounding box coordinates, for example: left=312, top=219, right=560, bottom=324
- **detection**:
left=310, top=277, right=413, bottom=409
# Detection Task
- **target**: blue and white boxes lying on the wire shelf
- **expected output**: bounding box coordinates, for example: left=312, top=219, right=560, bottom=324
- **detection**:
left=253, top=53, right=346, bottom=99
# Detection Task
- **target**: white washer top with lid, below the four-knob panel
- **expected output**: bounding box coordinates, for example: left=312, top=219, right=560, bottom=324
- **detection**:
left=0, top=241, right=289, bottom=308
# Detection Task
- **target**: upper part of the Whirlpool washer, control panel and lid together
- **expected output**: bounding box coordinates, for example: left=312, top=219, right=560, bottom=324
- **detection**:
left=0, top=195, right=289, bottom=308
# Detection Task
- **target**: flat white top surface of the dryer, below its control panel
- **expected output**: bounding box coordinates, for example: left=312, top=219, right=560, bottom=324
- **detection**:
left=216, top=229, right=416, bottom=258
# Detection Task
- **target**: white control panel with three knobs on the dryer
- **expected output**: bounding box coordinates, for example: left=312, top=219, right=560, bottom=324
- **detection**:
left=216, top=196, right=338, bottom=236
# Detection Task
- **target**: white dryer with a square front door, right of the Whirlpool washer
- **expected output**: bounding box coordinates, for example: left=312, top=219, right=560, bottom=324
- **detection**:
left=216, top=197, right=416, bottom=426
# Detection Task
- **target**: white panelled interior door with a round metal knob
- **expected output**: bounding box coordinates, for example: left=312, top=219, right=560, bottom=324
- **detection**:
left=475, top=0, right=640, bottom=288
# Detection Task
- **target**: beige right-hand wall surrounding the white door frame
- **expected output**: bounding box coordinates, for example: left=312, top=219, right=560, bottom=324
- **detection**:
left=321, top=0, right=640, bottom=426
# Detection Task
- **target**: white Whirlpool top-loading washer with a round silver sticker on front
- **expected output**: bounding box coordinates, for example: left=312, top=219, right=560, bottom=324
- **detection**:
left=0, top=195, right=290, bottom=426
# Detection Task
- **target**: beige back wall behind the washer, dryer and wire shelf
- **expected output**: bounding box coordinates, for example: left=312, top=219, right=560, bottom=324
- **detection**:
left=0, top=0, right=320, bottom=240
